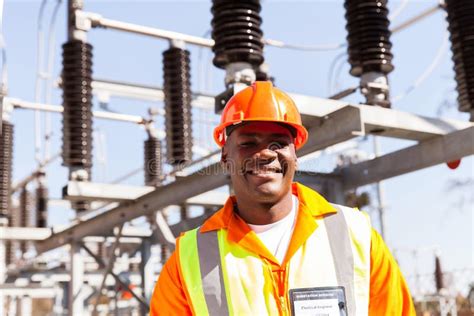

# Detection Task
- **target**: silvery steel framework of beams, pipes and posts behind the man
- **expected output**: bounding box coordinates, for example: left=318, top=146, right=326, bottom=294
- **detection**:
left=0, top=0, right=474, bottom=315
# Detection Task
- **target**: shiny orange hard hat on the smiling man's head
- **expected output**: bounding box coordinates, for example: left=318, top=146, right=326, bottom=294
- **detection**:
left=214, top=81, right=308, bottom=149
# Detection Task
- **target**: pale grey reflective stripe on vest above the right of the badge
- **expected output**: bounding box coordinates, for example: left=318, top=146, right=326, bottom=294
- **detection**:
left=324, top=204, right=356, bottom=315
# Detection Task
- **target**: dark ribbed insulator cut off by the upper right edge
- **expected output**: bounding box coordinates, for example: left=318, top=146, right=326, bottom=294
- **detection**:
left=446, top=0, right=474, bottom=122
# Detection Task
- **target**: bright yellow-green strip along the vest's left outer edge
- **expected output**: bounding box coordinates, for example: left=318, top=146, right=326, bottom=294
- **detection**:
left=178, top=229, right=209, bottom=315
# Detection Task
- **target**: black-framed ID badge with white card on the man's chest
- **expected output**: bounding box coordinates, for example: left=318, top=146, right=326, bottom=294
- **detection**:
left=290, top=286, right=347, bottom=316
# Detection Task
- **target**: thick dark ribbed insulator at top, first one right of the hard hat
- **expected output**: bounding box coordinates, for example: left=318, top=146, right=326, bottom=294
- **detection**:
left=344, top=0, right=394, bottom=77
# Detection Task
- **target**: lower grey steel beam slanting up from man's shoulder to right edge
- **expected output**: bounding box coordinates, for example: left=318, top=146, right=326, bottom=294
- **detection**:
left=340, top=126, right=474, bottom=190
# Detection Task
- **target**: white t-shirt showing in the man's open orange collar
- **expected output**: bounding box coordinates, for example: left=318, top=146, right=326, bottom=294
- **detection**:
left=248, top=195, right=298, bottom=263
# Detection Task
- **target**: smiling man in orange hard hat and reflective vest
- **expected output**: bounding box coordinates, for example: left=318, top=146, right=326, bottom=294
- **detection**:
left=151, top=82, right=414, bottom=315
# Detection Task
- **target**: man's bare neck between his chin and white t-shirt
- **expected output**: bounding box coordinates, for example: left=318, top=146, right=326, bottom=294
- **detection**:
left=236, top=190, right=293, bottom=225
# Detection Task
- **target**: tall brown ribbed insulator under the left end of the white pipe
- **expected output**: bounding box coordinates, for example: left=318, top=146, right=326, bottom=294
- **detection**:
left=62, top=40, right=92, bottom=173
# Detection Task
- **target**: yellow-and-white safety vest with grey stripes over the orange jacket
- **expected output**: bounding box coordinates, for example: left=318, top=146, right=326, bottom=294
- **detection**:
left=177, top=205, right=371, bottom=315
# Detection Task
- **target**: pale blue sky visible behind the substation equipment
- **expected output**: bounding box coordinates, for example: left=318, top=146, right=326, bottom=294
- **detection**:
left=3, top=0, right=474, bottom=291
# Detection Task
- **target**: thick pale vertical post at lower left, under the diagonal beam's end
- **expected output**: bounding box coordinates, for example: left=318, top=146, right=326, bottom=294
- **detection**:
left=68, top=242, right=85, bottom=316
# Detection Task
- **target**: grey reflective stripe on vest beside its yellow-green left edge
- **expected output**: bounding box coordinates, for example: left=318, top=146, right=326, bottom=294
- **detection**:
left=197, top=230, right=229, bottom=316
